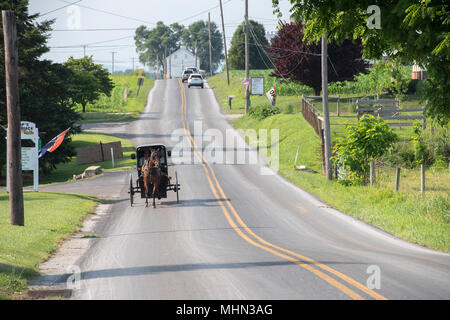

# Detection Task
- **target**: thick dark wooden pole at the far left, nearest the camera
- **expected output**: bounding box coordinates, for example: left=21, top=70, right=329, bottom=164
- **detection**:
left=2, top=11, right=25, bottom=226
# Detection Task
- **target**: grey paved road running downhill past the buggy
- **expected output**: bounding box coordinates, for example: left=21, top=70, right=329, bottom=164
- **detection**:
left=67, top=79, right=450, bottom=299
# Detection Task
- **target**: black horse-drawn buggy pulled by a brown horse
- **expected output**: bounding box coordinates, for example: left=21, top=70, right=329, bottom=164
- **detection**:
left=128, top=144, right=180, bottom=208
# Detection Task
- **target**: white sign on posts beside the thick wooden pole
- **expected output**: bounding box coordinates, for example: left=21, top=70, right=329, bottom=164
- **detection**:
left=6, top=121, right=39, bottom=192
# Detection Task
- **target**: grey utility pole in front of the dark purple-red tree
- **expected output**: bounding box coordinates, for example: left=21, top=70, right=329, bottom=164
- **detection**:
left=321, top=36, right=333, bottom=180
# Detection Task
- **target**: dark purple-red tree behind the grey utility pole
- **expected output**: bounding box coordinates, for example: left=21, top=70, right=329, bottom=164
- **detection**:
left=268, top=23, right=367, bottom=96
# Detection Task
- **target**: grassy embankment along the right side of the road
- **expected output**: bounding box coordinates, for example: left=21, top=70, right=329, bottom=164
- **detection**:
left=209, top=73, right=450, bottom=252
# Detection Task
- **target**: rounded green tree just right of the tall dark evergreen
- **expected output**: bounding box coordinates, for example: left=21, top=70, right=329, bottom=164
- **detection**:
left=64, top=56, right=114, bottom=112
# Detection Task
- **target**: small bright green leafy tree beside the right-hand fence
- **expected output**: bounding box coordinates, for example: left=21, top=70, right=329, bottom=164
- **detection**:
left=332, top=115, right=398, bottom=183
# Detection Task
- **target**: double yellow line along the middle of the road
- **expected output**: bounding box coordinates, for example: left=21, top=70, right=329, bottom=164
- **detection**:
left=179, top=80, right=386, bottom=300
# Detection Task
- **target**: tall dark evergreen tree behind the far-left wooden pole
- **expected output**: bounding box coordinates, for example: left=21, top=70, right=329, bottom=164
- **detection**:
left=0, top=0, right=79, bottom=176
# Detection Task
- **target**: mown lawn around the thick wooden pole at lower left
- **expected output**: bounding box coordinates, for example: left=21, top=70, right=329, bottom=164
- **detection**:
left=0, top=192, right=98, bottom=299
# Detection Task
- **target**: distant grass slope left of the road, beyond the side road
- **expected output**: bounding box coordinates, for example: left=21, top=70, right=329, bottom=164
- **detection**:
left=77, top=75, right=155, bottom=123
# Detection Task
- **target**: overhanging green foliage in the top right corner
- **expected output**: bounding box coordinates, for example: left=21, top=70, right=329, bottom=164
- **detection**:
left=272, top=0, right=450, bottom=125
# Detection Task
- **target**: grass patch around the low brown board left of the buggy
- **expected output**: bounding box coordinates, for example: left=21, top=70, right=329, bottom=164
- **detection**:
left=40, top=132, right=135, bottom=184
